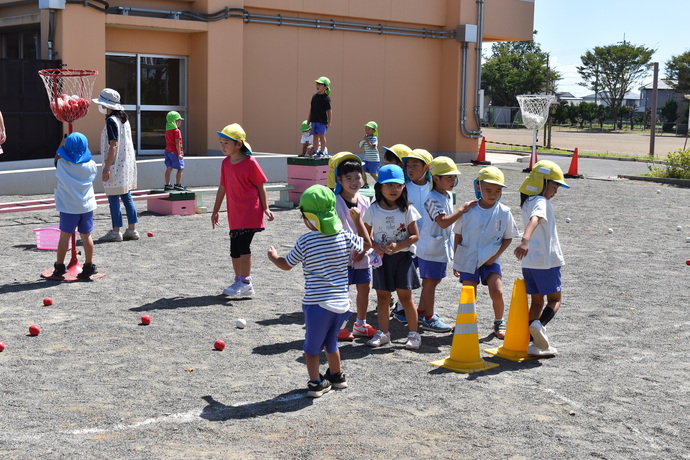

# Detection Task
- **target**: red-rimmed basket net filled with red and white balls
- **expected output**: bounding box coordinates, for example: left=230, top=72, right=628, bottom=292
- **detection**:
left=38, top=69, right=98, bottom=123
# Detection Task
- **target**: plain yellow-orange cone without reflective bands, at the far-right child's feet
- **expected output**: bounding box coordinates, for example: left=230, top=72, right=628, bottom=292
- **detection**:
left=484, top=278, right=537, bottom=361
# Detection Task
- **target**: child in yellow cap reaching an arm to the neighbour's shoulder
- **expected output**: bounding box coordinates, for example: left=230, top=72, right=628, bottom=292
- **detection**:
left=417, top=156, right=476, bottom=332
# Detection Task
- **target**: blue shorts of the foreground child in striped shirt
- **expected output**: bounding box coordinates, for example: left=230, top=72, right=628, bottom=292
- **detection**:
left=302, top=304, right=352, bottom=355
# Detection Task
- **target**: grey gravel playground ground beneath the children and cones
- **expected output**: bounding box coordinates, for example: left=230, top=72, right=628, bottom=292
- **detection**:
left=0, top=166, right=690, bottom=459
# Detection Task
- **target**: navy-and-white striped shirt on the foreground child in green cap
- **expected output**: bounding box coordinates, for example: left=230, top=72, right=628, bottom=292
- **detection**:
left=285, top=230, right=364, bottom=313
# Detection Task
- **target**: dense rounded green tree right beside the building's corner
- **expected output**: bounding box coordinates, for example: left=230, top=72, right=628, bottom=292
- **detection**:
left=482, top=31, right=563, bottom=107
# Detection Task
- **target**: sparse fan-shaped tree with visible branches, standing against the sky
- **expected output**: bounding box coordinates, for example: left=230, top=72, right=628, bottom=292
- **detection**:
left=577, top=42, right=654, bottom=126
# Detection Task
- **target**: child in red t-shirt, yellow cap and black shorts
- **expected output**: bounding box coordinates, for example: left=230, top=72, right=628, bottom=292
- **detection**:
left=211, top=123, right=273, bottom=297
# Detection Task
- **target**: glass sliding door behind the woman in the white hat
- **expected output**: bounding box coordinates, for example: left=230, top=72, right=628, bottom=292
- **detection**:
left=105, top=53, right=187, bottom=155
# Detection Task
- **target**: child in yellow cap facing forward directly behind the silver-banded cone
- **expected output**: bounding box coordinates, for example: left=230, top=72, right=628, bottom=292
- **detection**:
left=453, top=166, right=520, bottom=339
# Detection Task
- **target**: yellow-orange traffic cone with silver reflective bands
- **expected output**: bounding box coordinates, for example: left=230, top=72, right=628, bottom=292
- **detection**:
left=429, top=286, right=498, bottom=374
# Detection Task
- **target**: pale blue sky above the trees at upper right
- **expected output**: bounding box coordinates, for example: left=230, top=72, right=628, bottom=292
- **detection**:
left=528, top=0, right=690, bottom=96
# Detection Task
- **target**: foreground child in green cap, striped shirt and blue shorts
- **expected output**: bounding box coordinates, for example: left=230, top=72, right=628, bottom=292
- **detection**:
left=268, top=185, right=371, bottom=398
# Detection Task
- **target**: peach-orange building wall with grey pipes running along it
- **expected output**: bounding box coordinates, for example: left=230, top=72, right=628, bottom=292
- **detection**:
left=0, top=0, right=534, bottom=160
